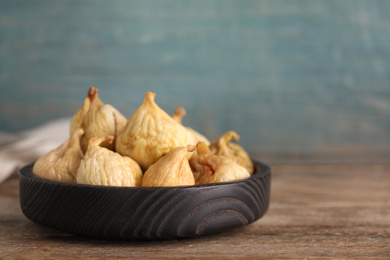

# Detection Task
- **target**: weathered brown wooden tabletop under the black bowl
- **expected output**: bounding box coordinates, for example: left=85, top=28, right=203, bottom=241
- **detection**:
left=0, top=164, right=390, bottom=259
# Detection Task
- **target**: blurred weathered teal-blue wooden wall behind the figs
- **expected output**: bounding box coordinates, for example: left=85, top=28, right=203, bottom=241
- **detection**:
left=0, top=0, right=390, bottom=163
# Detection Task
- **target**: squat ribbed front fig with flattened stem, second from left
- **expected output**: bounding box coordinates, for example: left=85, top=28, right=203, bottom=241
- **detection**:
left=76, top=136, right=142, bottom=187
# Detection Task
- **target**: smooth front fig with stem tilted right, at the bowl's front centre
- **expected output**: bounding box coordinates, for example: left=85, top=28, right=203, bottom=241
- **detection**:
left=141, top=145, right=195, bottom=187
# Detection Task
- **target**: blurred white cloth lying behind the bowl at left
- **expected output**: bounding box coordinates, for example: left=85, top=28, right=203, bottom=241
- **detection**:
left=0, top=118, right=71, bottom=183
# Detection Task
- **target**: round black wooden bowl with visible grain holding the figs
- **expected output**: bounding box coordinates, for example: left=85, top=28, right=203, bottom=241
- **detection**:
left=20, top=162, right=271, bottom=239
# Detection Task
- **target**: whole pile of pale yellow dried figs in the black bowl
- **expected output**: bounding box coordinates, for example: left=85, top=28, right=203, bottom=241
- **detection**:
left=33, top=87, right=255, bottom=187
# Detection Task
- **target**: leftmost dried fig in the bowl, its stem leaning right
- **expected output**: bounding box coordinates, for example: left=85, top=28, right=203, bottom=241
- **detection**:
left=33, top=128, right=84, bottom=183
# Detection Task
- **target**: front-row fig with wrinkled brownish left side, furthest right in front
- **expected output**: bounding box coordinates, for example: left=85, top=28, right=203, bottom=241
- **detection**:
left=190, top=142, right=250, bottom=185
